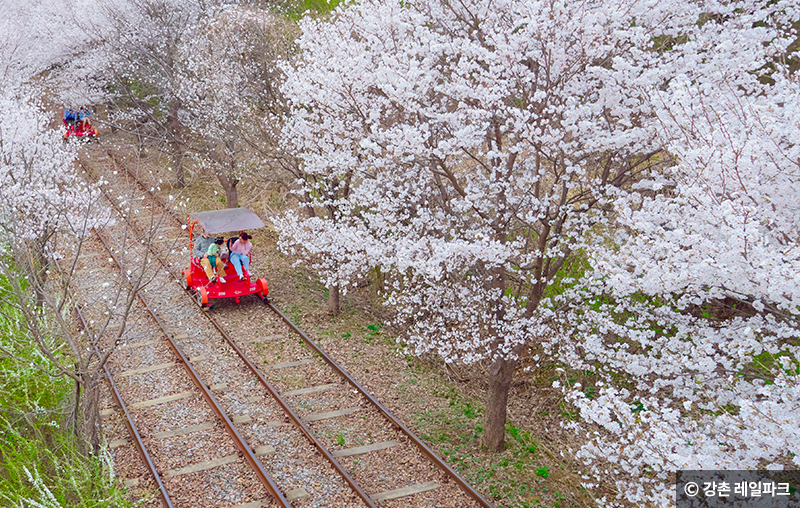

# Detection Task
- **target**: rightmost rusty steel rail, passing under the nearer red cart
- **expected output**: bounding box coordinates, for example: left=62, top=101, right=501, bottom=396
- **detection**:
left=96, top=152, right=494, bottom=508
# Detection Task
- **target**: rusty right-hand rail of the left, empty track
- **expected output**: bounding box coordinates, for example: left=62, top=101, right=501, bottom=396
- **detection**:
left=94, top=229, right=291, bottom=508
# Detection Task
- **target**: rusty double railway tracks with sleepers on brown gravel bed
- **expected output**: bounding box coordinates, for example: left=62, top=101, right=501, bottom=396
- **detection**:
left=70, top=150, right=491, bottom=508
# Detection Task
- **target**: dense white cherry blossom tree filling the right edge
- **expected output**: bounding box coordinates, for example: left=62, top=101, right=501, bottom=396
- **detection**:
left=553, top=17, right=800, bottom=507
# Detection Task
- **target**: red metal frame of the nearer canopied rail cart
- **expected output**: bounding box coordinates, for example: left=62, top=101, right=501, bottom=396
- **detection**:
left=183, top=218, right=269, bottom=308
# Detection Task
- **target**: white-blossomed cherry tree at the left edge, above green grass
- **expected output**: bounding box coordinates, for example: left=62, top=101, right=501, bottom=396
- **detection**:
left=0, top=87, right=108, bottom=450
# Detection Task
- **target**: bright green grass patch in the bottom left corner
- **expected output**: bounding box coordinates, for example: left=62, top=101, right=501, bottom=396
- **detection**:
left=0, top=280, right=128, bottom=508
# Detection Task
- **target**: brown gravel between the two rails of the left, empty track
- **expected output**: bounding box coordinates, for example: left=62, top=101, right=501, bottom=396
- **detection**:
left=76, top=226, right=282, bottom=507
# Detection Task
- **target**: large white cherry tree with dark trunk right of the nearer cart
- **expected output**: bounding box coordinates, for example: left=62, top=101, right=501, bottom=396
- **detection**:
left=278, top=0, right=698, bottom=449
